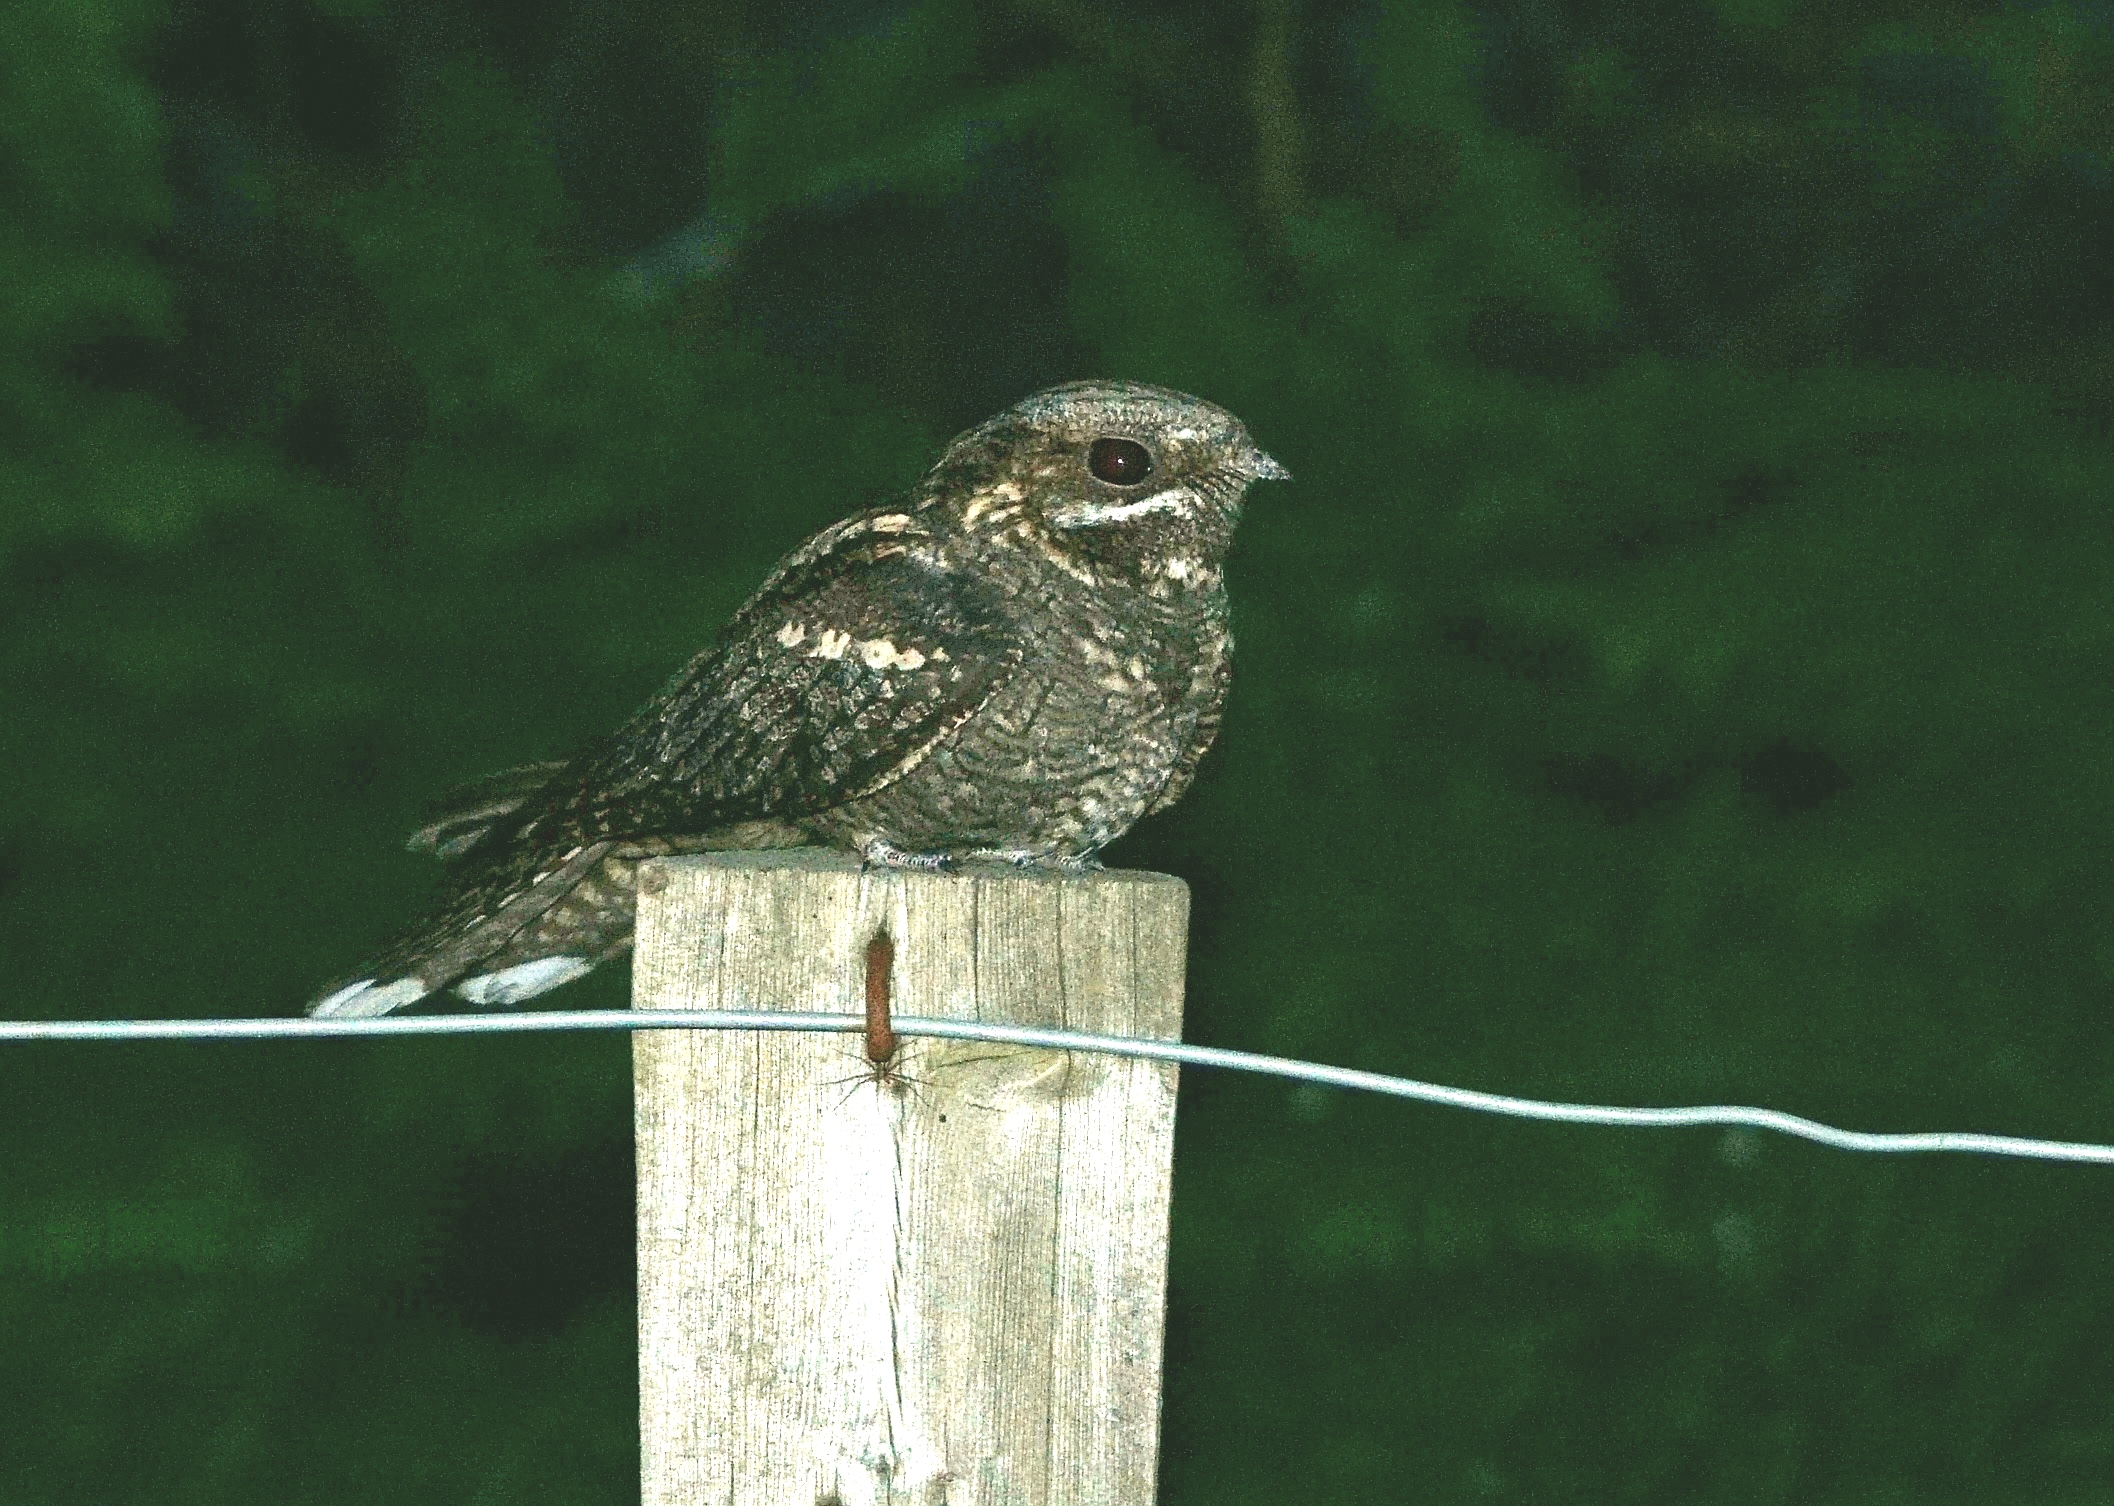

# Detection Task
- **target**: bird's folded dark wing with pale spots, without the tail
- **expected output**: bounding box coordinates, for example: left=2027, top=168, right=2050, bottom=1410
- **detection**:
left=518, top=512, right=1021, bottom=846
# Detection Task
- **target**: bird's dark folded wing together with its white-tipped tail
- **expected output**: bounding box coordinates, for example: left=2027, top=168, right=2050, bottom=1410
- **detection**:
left=311, top=512, right=1021, bottom=1013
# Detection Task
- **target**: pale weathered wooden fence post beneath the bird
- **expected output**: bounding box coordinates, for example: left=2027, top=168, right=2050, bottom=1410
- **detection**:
left=632, top=850, right=1188, bottom=1506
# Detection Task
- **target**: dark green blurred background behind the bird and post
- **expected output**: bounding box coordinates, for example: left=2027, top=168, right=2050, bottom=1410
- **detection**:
left=0, top=0, right=2114, bottom=1506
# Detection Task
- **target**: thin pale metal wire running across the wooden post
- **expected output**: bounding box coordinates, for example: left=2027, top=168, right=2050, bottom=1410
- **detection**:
left=16, top=1009, right=2114, bottom=1163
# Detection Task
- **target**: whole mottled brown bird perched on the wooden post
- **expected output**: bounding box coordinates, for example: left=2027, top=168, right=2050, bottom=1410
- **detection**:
left=309, top=383, right=1290, bottom=1015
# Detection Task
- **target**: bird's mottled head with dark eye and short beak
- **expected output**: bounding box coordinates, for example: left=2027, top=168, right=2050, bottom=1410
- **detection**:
left=920, top=381, right=1292, bottom=590
